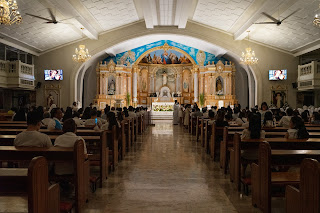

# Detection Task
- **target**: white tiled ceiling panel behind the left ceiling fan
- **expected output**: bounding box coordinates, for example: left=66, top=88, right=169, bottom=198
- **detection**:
left=0, top=0, right=81, bottom=52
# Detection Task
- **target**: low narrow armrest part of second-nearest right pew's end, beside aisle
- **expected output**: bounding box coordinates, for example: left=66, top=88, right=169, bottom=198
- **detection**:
left=251, top=163, right=260, bottom=207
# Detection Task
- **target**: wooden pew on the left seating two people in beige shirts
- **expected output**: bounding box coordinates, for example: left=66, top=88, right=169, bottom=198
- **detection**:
left=0, top=141, right=89, bottom=212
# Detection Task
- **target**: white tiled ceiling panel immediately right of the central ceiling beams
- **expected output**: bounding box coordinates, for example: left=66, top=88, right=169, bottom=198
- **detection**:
left=193, top=0, right=254, bottom=31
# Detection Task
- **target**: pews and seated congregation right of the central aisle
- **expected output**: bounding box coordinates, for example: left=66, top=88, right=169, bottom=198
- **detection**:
left=179, top=102, right=320, bottom=213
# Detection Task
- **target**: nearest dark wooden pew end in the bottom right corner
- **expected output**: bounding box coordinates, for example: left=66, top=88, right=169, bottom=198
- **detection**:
left=286, top=158, right=320, bottom=213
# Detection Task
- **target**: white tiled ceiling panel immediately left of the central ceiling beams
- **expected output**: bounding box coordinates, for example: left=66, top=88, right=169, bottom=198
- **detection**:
left=81, top=0, right=139, bottom=30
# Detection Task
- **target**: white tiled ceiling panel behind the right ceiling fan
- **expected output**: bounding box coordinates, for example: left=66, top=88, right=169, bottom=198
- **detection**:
left=250, top=0, right=320, bottom=51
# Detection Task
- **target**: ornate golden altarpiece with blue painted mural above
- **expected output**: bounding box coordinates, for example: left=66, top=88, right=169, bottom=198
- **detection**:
left=94, top=40, right=237, bottom=110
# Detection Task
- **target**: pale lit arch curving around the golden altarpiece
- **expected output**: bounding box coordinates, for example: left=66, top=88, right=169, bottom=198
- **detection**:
left=74, top=34, right=257, bottom=107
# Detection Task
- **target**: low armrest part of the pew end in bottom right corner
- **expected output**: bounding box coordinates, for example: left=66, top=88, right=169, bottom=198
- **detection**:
left=286, top=186, right=301, bottom=213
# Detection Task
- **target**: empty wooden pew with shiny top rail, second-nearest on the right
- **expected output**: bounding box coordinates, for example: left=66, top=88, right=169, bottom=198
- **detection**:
left=251, top=142, right=320, bottom=213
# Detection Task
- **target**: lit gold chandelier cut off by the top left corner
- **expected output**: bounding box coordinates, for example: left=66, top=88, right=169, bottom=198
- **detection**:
left=0, top=0, right=22, bottom=25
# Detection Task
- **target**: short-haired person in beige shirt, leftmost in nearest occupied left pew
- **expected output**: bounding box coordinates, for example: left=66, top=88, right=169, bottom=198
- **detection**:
left=14, top=111, right=52, bottom=147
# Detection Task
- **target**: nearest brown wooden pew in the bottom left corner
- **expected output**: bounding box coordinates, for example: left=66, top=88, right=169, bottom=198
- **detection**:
left=0, top=157, right=60, bottom=213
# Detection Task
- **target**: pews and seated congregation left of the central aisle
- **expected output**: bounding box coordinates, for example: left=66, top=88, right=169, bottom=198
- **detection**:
left=0, top=103, right=149, bottom=213
